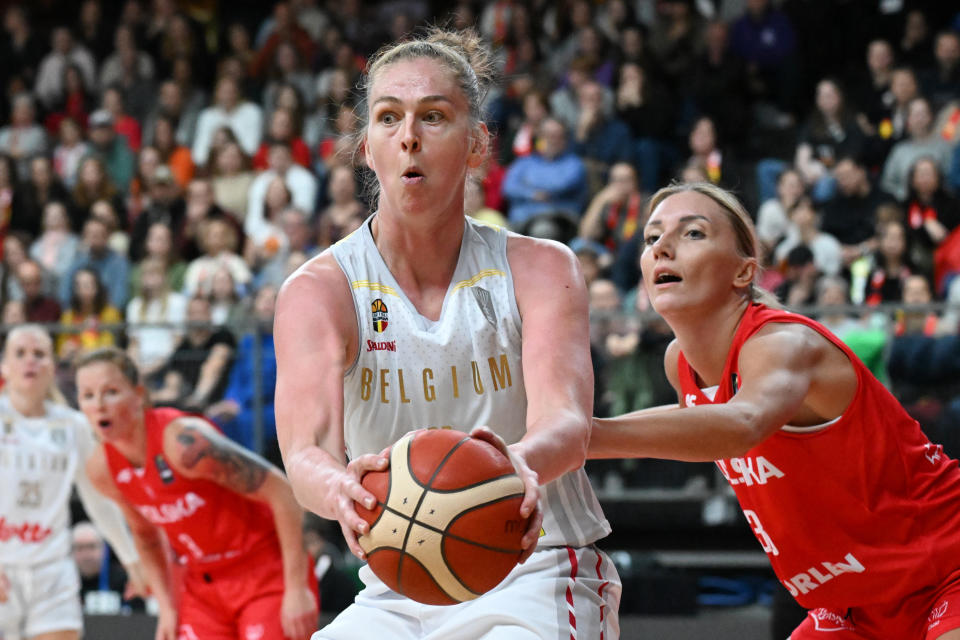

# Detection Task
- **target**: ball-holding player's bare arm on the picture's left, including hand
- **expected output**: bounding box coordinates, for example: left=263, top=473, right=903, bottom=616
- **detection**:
left=274, top=253, right=387, bottom=558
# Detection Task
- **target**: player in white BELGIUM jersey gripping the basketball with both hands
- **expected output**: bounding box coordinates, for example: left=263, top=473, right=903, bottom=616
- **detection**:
left=274, top=30, right=620, bottom=640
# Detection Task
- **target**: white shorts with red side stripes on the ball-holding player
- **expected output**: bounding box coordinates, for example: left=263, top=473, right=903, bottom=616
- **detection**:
left=311, top=547, right=621, bottom=640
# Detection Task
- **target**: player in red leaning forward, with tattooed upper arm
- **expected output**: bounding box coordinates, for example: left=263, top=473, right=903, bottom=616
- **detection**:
left=77, top=348, right=317, bottom=640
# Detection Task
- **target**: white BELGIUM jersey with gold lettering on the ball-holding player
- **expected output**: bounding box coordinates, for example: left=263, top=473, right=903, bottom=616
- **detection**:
left=333, top=216, right=610, bottom=546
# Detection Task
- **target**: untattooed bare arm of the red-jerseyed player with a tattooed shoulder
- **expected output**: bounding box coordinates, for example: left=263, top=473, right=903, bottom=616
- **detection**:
left=87, top=446, right=177, bottom=640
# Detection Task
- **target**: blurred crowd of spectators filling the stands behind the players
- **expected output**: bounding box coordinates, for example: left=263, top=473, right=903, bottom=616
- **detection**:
left=0, top=0, right=960, bottom=457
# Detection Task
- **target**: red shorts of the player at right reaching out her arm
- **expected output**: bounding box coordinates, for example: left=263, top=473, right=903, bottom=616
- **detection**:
left=790, top=573, right=960, bottom=640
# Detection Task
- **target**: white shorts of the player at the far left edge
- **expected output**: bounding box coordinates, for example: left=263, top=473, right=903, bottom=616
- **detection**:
left=0, top=558, right=83, bottom=640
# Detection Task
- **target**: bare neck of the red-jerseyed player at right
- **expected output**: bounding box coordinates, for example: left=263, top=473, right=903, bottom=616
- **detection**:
left=664, top=296, right=750, bottom=386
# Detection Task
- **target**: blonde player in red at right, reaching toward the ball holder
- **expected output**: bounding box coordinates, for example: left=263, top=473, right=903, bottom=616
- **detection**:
left=589, top=183, right=960, bottom=640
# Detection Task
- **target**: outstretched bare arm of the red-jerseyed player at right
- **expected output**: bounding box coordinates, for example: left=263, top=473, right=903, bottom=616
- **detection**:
left=590, top=325, right=857, bottom=461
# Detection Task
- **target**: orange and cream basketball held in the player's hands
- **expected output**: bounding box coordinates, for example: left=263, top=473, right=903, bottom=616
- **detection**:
left=355, top=429, right=527, bottom=604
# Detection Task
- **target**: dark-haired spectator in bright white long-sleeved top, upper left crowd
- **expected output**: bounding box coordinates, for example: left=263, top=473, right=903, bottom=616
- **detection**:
left=193, top=76, right=263, bottom=166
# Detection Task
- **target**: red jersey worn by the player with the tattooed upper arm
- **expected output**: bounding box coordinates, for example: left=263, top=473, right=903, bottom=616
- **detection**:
left=104, top=409, right=279, bottom=568
